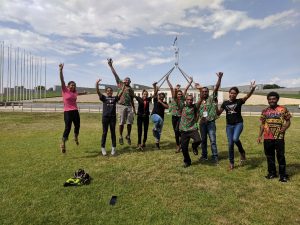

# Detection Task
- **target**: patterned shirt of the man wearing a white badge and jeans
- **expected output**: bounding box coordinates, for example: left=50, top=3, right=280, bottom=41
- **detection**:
left=199, top=93, right=218, bottom=121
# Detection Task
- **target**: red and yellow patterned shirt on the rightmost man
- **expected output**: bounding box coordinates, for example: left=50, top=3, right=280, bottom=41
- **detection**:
left=260, top=105, right=291, bottom=140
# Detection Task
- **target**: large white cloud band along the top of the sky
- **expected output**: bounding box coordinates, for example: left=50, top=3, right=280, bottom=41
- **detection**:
left=0, top=0, right=298, bottom=41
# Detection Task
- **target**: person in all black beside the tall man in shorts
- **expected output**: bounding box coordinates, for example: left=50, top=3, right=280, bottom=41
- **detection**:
left=134, top=84, right=154, bottom=150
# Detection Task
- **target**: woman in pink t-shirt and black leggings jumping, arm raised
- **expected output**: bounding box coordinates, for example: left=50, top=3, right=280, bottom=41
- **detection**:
left=59, top=63, right=86, bottom=153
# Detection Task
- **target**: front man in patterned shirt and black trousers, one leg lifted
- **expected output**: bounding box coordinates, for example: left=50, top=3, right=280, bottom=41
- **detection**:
left=179, top=95, right=201, bottom=168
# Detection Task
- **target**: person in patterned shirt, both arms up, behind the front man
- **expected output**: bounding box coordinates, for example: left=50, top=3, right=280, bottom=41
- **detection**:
left=166, top=75, right=192, bottom=153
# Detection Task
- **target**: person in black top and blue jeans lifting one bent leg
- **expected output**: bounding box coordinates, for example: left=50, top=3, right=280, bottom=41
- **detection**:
left=151, top=83, right=169, bottom=149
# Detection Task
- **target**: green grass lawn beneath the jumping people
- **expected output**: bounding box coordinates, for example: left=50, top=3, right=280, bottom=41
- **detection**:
left=0, top=113, right=300, bottom=225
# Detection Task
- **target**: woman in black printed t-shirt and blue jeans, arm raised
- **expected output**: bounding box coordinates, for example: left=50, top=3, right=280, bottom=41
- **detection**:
left=218, top=81, right=256, bottom=170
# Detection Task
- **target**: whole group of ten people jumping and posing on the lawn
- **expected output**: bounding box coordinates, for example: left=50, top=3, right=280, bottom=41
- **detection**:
left=59, top=59, right=291, bottom=182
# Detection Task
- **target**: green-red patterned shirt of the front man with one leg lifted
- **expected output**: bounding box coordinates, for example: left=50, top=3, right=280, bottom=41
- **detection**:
left=179, top=104, right=199, bottom=131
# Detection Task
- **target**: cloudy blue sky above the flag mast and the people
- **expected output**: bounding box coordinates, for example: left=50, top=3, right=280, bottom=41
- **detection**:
left=0, top=0, right=300, bottom=87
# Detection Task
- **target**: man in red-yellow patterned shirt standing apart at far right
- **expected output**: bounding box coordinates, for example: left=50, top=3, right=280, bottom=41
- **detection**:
left=257, top=92, right=291, bottom=182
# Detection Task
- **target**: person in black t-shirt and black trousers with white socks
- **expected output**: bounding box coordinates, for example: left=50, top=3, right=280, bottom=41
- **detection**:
left=96, top=79, right=125, bottom=155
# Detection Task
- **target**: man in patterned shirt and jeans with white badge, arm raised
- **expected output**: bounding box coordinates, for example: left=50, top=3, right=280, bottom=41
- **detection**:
left=199, top=72, right=223, bottom=164
